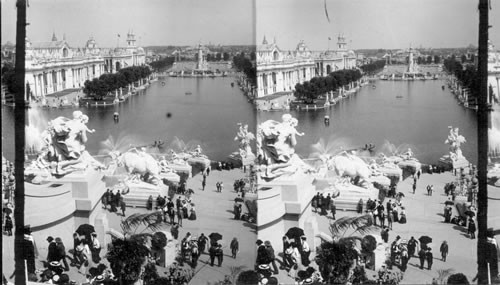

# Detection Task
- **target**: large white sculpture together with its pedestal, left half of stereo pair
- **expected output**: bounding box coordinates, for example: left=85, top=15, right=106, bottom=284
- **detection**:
left=24, top=109, right=109, bottom=252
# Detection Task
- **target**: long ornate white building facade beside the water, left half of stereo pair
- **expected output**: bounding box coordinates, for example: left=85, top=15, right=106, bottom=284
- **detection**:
left=25, top=34, right=146, bottom=98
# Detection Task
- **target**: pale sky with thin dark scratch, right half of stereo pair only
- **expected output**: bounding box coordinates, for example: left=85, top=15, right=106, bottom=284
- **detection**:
left=256, top=0, right=500, bottom=50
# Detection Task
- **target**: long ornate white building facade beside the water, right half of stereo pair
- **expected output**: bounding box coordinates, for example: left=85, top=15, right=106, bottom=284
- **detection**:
left=257, top=36, right=356, bottom=98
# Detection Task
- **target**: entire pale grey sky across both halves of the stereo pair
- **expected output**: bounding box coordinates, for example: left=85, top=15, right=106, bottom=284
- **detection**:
left=1, top=0, right=500, bottom=50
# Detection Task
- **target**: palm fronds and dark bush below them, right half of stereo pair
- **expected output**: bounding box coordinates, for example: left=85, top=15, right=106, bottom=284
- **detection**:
left=316, top=215, right=375, bottom=284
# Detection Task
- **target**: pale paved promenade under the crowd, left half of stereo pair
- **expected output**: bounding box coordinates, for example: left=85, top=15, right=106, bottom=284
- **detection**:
left=2, top=166, right=256, bottom=284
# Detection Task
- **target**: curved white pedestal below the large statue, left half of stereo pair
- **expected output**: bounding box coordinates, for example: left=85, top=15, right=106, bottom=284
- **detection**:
left=24, top=168, right=110, bottom=256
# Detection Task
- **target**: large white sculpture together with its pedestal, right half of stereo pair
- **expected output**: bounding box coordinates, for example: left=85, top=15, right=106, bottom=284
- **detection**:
left=257, top=114, right=319, bottom=251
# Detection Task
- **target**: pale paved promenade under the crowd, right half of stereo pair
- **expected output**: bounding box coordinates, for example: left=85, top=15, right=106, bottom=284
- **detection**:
left=275, top=172, right=500, bottom=284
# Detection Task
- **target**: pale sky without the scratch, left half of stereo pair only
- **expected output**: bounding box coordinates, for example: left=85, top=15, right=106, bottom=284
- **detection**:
left=1, top=0, right=255, bottom=47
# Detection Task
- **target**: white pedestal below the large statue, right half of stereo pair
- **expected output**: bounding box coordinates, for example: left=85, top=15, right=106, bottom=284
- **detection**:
left=257, top=173, right=320, bottom=251
